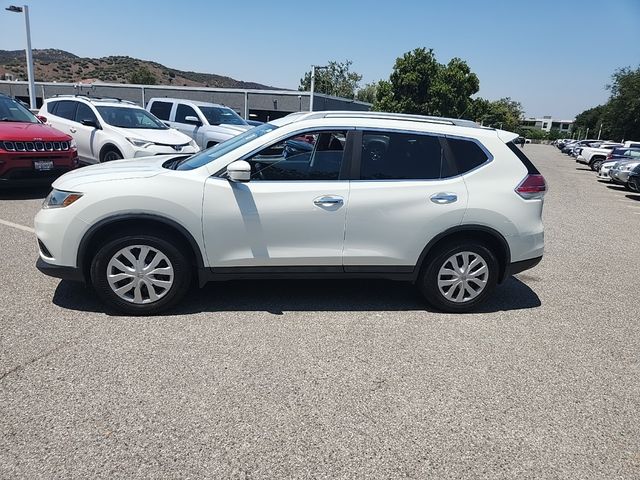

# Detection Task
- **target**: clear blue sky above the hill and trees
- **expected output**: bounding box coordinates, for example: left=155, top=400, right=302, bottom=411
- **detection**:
left=0, top=0, right=640, bottom=118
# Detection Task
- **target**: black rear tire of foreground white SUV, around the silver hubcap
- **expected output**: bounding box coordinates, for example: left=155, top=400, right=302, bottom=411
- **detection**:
left=418, top=241, right=500, bottom=313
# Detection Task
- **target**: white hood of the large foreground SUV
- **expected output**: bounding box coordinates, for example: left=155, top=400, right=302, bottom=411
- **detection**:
left=52, top=155, right=175, bottom=191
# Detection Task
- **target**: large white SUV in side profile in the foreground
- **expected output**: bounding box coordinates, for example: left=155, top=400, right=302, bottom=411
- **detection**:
left=35, top=112, right=546, bottom=314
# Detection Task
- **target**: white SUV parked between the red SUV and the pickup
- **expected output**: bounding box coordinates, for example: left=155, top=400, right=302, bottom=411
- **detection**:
left=39, top=95, right=200, bottom=163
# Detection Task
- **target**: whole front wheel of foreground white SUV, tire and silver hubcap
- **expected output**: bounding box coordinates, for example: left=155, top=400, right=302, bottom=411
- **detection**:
left=91, top=234, right=191, bottom=315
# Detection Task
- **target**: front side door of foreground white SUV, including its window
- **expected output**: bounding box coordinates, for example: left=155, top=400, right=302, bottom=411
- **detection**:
left=203, top=129, right=352, bottom=271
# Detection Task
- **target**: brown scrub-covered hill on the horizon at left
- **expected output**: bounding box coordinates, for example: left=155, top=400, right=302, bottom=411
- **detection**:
left=0, top=49, right=274, bottom=89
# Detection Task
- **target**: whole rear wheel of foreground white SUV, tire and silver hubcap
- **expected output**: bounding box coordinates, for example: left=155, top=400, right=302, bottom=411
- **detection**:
left=419, top=242, right=499, bottom=313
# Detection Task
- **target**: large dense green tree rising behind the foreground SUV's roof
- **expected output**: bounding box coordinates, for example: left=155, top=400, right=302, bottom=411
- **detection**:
left=374, top=48, right=480, bottom=117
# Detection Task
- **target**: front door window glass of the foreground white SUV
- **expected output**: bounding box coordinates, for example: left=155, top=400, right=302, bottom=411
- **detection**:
left=247, top=131, right=347, bottom=180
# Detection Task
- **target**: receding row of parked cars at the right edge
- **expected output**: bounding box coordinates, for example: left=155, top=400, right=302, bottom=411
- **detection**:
left=556, top=140, right=640, bottom=192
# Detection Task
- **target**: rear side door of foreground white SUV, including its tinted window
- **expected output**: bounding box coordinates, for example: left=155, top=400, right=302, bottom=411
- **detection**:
left=344, top=130, right=467, bottom=272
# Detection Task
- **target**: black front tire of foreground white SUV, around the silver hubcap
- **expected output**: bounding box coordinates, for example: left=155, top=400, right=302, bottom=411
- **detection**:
left=90, top=233, right=193, bottom=315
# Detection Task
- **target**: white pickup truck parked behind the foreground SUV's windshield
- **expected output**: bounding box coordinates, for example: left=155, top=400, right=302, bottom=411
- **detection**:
left=147, top=98, right=253, bottom=149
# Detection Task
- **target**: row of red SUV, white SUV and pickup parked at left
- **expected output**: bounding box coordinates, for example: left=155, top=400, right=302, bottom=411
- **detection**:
left=0, top=95, right=255, bottom=186
